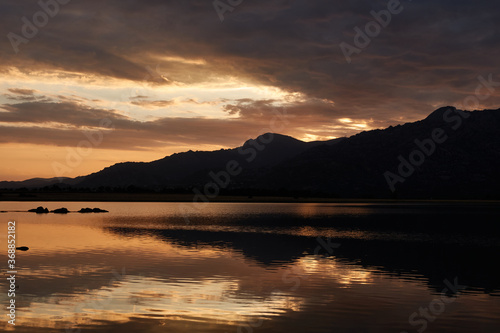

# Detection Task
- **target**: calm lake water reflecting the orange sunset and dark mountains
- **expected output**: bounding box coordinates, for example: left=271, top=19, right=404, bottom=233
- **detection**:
left=0, top=202, right=500, bottom=333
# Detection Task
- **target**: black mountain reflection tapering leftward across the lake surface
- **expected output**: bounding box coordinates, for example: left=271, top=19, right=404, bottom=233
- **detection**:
left=106, top=227, right=500, bottom=293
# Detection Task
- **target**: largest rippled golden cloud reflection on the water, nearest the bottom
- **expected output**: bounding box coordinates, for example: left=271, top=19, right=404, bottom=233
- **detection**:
left=11, top=276, right=304, bottom=328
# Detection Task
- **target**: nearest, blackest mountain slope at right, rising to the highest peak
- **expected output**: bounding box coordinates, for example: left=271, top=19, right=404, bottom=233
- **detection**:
left=256, top=107, right=500, bottom=199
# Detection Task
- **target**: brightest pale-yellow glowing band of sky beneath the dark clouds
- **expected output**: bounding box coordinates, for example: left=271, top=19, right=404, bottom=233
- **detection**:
left=0, top=66, right=304, bottom=121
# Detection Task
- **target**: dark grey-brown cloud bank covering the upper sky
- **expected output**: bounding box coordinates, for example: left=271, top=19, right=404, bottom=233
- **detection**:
left=0, top=0, right=500, bottom=135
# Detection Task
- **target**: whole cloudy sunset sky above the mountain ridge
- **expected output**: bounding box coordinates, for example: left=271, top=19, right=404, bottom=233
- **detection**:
left=0, top=0, right=500, bottom=180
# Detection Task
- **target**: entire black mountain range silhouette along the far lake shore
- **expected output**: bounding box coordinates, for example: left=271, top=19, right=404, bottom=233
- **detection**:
left=0, top=107, right=500, bottom=199
